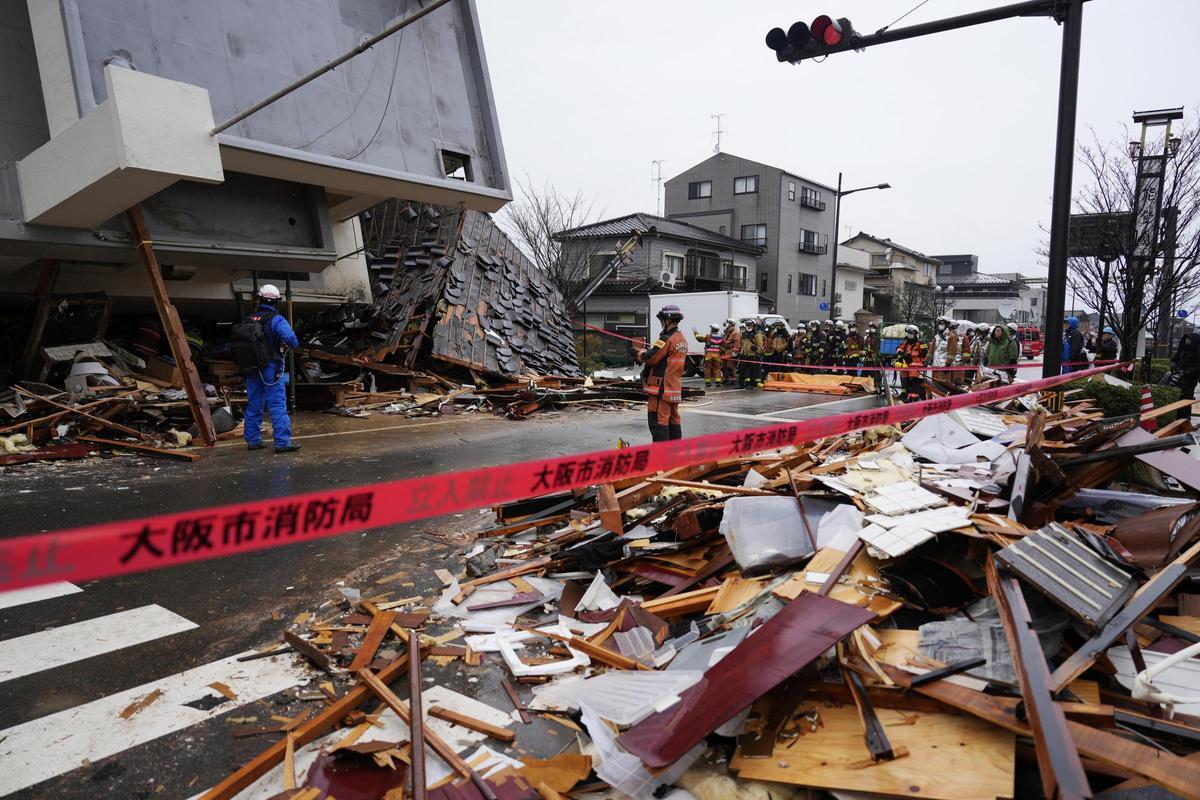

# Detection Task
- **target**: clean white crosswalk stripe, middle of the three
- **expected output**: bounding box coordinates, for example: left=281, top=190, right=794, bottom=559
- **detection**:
left=0, top=606, right=197, bottom=682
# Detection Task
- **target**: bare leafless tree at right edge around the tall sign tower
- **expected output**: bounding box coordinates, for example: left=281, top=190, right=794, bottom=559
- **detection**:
left=1068, top=113, right=1200, bottom=353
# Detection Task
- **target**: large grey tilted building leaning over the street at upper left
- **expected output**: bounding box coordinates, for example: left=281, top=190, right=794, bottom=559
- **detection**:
left=0, top=0, right=511, bottom=318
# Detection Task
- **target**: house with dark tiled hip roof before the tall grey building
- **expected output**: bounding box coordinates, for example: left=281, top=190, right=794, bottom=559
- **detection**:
left=556, top=213, right=772, bottom=361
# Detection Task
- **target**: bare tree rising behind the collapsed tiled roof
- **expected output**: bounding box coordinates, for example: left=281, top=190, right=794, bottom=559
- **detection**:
left=499, top=176, right=602, bottom=312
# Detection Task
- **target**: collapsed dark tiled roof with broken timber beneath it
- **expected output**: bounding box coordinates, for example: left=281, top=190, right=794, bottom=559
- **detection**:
left=301, top=200, right=662, bottom=416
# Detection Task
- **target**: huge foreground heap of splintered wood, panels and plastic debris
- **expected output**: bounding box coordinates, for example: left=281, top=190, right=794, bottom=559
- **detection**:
left=204, top=381, right=1200, bottom=800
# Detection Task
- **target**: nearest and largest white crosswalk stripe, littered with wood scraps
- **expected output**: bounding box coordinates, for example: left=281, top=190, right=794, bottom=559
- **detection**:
left=0, top=652, right=307, bottom=796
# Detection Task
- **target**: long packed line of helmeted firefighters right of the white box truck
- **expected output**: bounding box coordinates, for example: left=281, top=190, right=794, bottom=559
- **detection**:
left=692, top=318, right=882, bottom=389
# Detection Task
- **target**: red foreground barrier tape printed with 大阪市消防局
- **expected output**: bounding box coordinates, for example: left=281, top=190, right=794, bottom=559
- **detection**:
left=0, top=367, right=1111, bottom=590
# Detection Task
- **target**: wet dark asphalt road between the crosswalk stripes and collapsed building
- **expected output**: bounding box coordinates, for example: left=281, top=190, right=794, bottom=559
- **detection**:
left=0, top=380, right=876, bottom=799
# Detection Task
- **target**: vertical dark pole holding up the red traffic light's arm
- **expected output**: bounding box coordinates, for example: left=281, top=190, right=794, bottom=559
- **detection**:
left=1042, top=0, right=1084, bottom=378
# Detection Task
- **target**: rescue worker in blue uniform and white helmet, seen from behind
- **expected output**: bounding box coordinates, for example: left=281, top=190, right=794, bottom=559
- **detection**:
left=244, top=283, right=300, bottom=453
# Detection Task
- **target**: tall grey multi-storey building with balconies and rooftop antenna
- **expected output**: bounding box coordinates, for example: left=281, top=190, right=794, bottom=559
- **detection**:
left=665, top=152, right=834, bottom=324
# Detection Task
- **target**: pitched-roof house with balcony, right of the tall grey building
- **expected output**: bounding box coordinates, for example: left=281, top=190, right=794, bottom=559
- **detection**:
left=838, top=231, right=941, bottom=321
